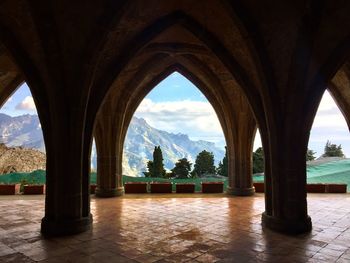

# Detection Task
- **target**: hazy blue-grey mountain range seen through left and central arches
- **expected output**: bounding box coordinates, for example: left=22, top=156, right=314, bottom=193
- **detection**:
left=0, top=113, right=225, bottom=176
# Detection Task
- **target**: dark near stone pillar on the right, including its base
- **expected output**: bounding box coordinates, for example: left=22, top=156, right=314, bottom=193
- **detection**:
left=262, top=127, right=312, bottom=234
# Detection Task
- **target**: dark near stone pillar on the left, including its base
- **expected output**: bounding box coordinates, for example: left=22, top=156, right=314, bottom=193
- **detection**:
left=41, top=107, right=92, bottom=236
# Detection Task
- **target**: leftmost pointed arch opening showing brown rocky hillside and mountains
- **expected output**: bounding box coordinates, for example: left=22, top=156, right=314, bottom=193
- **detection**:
left=0, top=82, right=46, bottom=191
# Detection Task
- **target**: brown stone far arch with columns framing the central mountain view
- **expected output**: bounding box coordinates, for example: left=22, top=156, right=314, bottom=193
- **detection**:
left=94, top=52, right=256, bottom=196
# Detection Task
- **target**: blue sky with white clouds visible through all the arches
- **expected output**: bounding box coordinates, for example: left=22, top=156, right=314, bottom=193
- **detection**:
left=0, top=72, right=350, bottom=157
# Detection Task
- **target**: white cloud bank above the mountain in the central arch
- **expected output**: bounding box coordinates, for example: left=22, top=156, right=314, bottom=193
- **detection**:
left=135, top=98, right=225, bottom=144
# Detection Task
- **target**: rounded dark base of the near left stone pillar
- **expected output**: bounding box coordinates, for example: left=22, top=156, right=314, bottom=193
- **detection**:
left=41, top=214, right=92, bottom=237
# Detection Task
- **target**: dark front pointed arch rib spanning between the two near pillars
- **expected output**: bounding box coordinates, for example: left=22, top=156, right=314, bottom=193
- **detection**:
left=88, top=11, right=264, bottom=134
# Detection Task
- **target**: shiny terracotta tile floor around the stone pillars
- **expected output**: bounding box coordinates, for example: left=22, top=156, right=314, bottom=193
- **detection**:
left=0, top=194, right=350, bottom=263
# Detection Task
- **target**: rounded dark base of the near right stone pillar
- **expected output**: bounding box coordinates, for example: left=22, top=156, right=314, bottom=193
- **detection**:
left=261, top=212, right=312, bottom=235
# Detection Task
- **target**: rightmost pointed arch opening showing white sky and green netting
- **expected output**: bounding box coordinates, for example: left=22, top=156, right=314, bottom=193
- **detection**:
left=307, top=89, right=350, bottom=190
